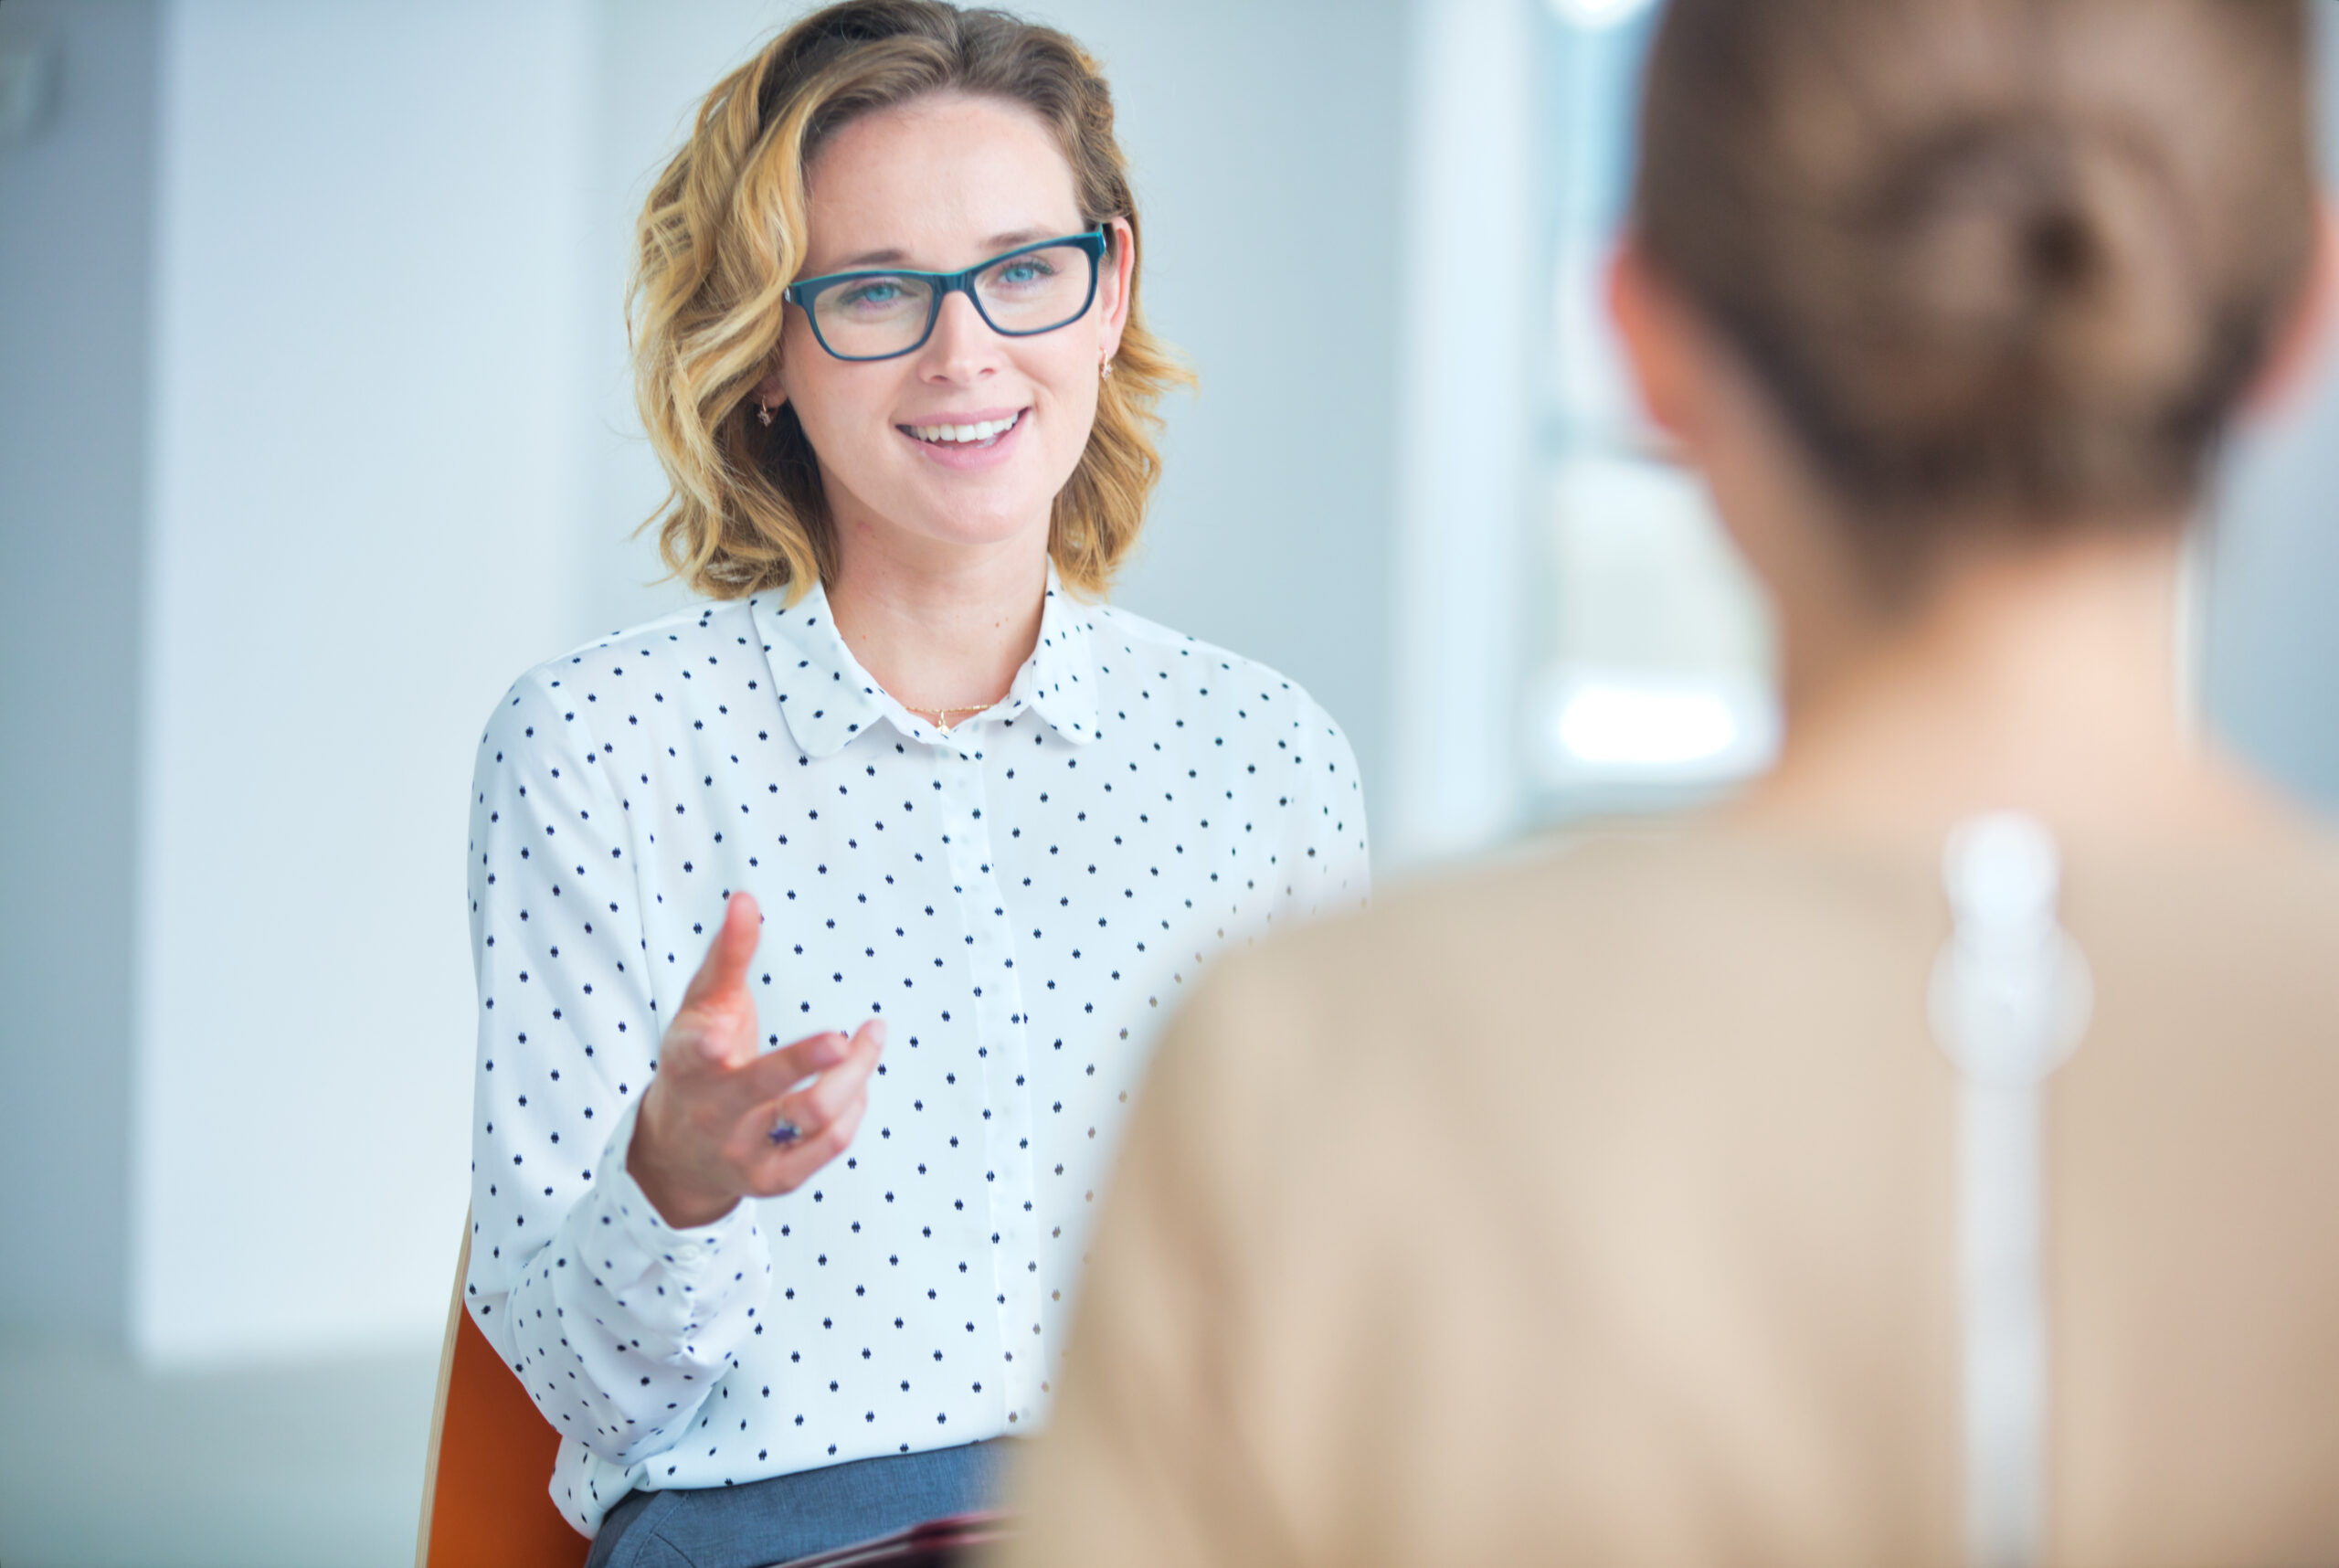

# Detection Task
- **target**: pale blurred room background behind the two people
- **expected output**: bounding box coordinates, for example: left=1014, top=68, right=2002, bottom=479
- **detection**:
left=0, top=0, right=2339, bottom=1568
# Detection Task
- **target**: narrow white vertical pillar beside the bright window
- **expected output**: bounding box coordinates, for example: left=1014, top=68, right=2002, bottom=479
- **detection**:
left=1373, top=0, right=1544, bottom=866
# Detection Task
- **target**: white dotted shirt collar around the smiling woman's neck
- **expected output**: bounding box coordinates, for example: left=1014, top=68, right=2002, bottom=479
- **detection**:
left=748, top=562, right=1097, bottom=758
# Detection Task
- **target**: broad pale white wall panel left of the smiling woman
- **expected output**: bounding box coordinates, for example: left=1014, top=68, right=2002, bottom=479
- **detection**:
left=133, top=0, right=592, bottom=1362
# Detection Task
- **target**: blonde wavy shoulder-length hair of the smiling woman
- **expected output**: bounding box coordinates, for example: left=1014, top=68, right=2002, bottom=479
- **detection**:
left=627, top=0, right=1193, bottom=601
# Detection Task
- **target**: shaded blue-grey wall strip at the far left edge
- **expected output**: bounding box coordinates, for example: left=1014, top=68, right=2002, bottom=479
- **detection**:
left=0, top=0, right=159, bottom=1339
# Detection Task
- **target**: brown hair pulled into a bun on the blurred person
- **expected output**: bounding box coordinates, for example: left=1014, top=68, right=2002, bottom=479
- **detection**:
left=1635, top=0, right=2315, bottom=573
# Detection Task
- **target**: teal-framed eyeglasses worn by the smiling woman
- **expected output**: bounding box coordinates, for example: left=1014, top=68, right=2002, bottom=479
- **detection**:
left=786, top=225, right=1111, bottom=360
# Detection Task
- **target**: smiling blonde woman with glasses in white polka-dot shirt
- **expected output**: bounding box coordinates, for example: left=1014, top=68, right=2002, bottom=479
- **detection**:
left=463, top=0, right=1366, bottom=1568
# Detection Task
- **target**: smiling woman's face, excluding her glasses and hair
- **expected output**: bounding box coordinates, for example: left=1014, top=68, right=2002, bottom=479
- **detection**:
left=757, top=93, right=1132, bottom=564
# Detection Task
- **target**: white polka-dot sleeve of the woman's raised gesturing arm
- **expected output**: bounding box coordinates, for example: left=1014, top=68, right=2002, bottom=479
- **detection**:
left=463, top=672, right=772, bottom=1467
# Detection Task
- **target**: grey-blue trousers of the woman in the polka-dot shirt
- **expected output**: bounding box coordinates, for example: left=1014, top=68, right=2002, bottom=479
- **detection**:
left=585, top=1437, right=1015, bottom=1568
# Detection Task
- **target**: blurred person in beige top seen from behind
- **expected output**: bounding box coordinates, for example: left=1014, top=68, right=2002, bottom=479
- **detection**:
left=1018, top=0, right=2339, bottom=1568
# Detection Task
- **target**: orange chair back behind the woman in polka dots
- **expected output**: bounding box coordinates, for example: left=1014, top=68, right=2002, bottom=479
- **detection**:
left=414, top=1214, right=592, bottom=1568
